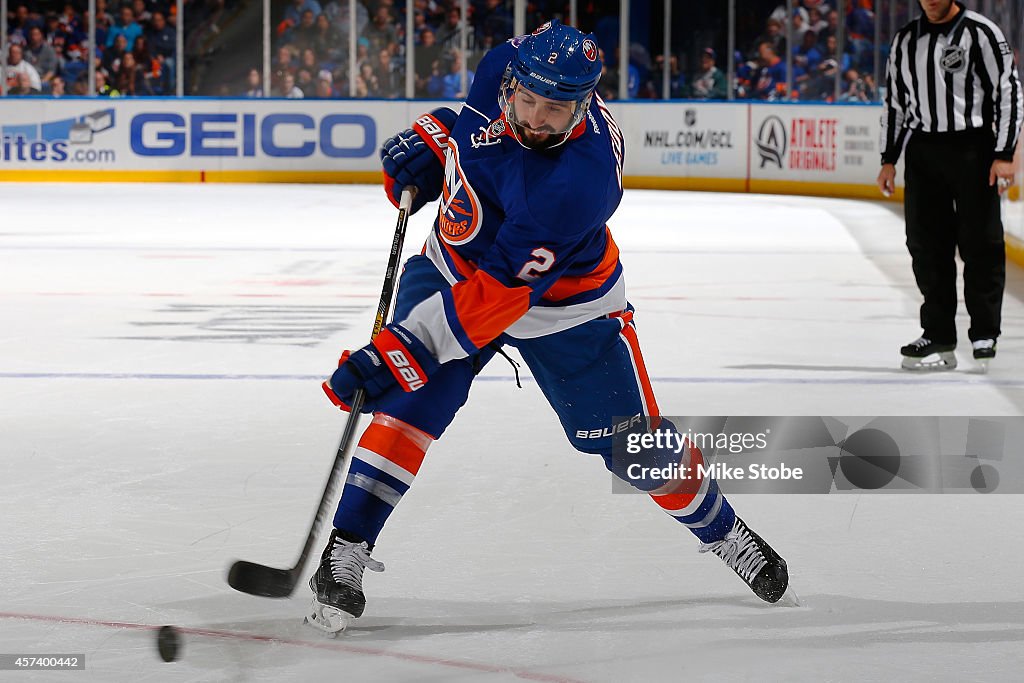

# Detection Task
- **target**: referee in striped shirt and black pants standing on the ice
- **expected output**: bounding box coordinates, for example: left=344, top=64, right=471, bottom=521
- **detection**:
left=878, top=0, right=1024, bottom=370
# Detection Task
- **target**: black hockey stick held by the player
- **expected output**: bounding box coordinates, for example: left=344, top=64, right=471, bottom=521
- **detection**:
left=227, top=187, right=415, bottom=598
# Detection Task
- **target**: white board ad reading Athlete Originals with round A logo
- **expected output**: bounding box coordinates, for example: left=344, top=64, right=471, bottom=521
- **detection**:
left=751, top=104, right=882, bottom=184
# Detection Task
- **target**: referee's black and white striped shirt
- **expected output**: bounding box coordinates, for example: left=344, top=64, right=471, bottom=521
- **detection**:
left=882, top=2, right=1024, bottom=164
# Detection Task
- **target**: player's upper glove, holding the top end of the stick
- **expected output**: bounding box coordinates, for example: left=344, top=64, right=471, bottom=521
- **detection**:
left=381, top=106, right=459, bottom=213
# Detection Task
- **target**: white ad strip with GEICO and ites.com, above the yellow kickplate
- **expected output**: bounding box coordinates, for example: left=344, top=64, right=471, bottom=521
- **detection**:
left=0, top=98, right=444, bottom=171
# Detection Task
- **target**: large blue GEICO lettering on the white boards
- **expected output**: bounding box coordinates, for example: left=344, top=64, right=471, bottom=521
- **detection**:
left=130, top=112, right=377, bottom=159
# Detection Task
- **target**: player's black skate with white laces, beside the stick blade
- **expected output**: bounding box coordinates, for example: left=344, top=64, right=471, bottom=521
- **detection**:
left=303, top=529, right=384, bottom=637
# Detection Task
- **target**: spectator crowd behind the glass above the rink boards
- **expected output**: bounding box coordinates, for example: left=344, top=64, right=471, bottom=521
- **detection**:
left=4, top=0, right=887, bottom=101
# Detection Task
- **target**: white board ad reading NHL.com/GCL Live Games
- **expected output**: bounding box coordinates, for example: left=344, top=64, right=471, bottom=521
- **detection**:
left=612, top=102, right=748, bottom=178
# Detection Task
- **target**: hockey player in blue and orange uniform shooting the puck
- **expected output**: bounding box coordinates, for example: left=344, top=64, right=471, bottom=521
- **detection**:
left=307, top=17, right=788, bottom=632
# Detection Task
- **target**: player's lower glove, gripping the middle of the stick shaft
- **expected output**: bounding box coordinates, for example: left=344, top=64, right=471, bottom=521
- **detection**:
left=324, top=325, right=440, bottom=413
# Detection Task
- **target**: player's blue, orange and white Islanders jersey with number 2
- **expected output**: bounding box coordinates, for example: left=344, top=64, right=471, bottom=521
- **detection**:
left=400, top=41, right=626, bottom=362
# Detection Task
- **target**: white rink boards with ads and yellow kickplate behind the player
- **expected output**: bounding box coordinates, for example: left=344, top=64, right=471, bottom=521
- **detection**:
left=0, top=98, right=909, bottom=197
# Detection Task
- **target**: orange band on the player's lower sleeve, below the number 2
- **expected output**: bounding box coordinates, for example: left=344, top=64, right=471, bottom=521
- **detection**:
left=452, top=270, right=529, bottom=348
